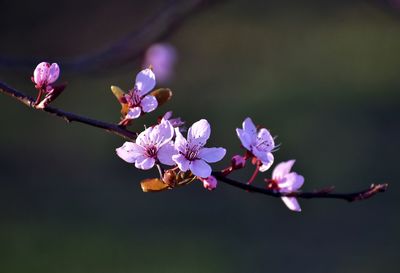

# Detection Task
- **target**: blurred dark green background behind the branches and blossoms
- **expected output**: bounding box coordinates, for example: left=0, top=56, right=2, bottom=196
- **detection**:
left=0, top=0, right=400, bottom=273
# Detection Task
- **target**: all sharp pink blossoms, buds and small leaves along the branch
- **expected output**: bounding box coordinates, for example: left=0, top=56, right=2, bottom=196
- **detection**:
left=32, top=62, right=304, bottom=211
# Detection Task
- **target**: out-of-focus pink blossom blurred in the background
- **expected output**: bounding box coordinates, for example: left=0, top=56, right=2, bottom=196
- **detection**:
left=144, top=43, right=177, bottom=82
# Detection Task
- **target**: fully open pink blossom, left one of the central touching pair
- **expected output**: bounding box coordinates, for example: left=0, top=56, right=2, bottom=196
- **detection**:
left=116, top=120, right=176, bottom=170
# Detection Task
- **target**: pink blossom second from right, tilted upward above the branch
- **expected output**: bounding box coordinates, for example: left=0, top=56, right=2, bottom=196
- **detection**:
left=236, top=118, right=275, bottom=172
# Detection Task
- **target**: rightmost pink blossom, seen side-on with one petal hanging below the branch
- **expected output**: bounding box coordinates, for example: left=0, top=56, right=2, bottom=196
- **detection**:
left=266, top=160, right=304, bottom=212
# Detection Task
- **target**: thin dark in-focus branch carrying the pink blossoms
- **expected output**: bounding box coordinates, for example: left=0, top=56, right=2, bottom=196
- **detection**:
left=0, top=81, right=388, bottom=202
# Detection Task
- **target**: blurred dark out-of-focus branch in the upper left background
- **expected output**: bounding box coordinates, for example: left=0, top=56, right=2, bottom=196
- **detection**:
left=0, top=0, right=221, bottom=71
